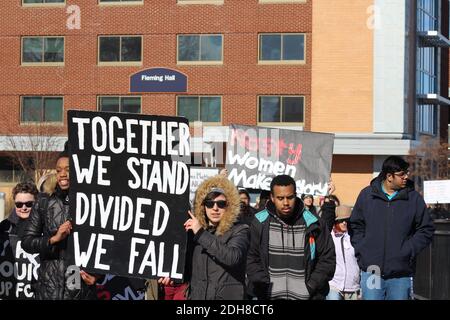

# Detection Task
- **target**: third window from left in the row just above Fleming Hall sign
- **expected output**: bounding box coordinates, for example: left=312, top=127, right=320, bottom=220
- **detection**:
left=178, top=34, right=223, bottom=64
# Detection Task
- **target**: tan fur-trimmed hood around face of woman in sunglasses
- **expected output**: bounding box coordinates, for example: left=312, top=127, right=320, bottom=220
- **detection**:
left=194, top=175, right=240, bottom=235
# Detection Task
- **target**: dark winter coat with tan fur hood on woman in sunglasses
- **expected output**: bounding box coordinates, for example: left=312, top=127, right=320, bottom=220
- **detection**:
left=187, top=176, right=249, bottom=300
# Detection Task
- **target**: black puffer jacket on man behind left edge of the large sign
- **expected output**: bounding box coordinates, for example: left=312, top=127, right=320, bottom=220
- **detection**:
left=22, top=188, right=96, bottom=300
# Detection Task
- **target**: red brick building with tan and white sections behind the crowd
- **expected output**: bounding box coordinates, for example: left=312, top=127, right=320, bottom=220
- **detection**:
left=0, top=0, right=449, bottom=208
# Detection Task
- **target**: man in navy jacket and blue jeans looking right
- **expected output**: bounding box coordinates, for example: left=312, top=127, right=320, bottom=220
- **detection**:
left=350, top=156, right=434, bottom=300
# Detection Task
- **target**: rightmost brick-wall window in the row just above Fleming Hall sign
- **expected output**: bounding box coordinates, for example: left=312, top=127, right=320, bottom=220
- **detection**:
left=259, top=33, right=305, bottom=63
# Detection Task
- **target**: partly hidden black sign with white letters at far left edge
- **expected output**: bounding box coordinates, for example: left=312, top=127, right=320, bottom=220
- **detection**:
left=0, top=232, right=39, bottom=300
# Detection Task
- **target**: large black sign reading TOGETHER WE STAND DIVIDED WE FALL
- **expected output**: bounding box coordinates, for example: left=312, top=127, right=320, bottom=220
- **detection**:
left=68, top=111, right=190, bottom=281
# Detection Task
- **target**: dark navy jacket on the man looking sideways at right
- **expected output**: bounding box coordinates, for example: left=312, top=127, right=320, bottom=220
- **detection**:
left=349, top=177, right=434, bottom=279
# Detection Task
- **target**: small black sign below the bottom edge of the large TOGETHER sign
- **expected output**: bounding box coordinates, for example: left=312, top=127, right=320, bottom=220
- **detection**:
left=97, top=274, right=145, bottom=300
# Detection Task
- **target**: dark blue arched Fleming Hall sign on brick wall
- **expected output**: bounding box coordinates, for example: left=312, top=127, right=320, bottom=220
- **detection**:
left=130, top=68, right=187, bottom=93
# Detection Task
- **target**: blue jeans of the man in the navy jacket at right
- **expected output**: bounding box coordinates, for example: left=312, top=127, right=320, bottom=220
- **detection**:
left=361, top=271, right=412, bottom=300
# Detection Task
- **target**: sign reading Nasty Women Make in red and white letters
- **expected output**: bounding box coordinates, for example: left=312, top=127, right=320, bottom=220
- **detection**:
left=226, top=125, right=334, bottom=195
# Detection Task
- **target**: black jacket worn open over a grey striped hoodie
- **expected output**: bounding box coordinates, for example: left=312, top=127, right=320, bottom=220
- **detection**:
left=247, top=198, right=336, bottom=300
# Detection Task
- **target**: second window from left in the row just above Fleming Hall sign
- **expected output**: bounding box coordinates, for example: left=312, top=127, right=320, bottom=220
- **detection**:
left=98, top=36, right=142, bottom=65
